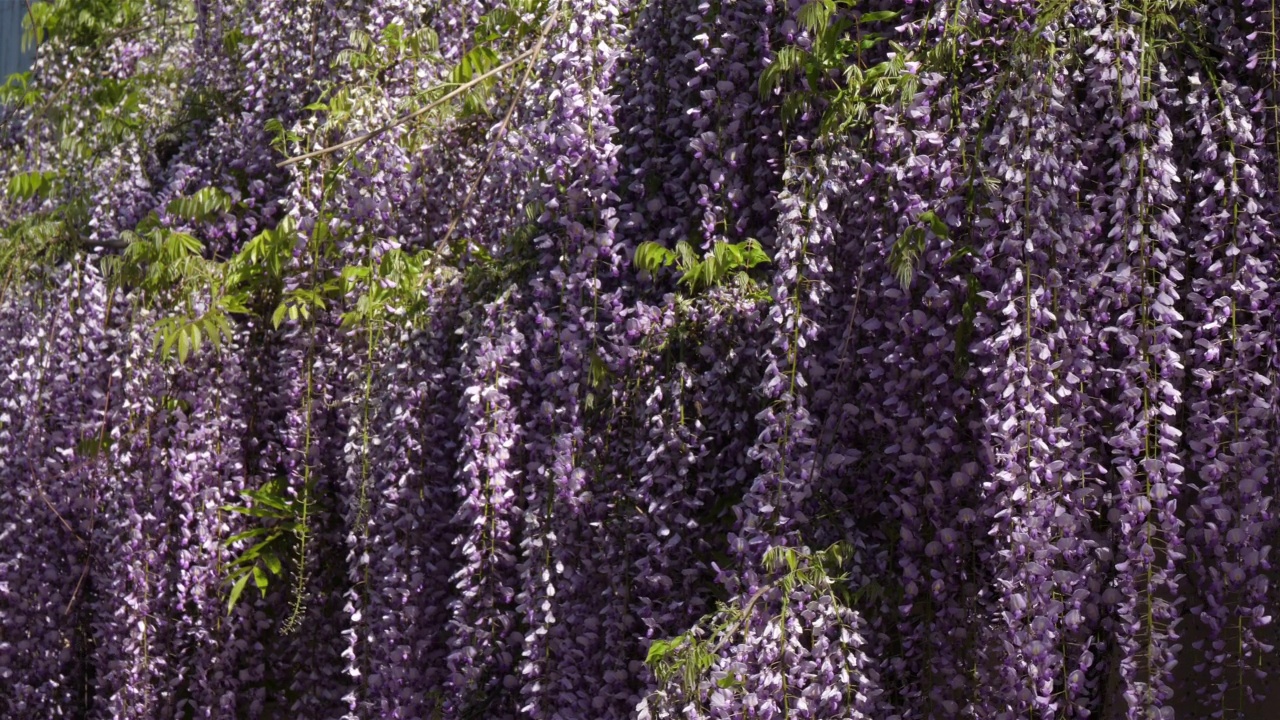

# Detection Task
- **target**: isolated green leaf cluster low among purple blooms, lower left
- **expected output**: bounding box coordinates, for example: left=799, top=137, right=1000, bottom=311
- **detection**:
left=223, top=478, right=308, bottom=612
